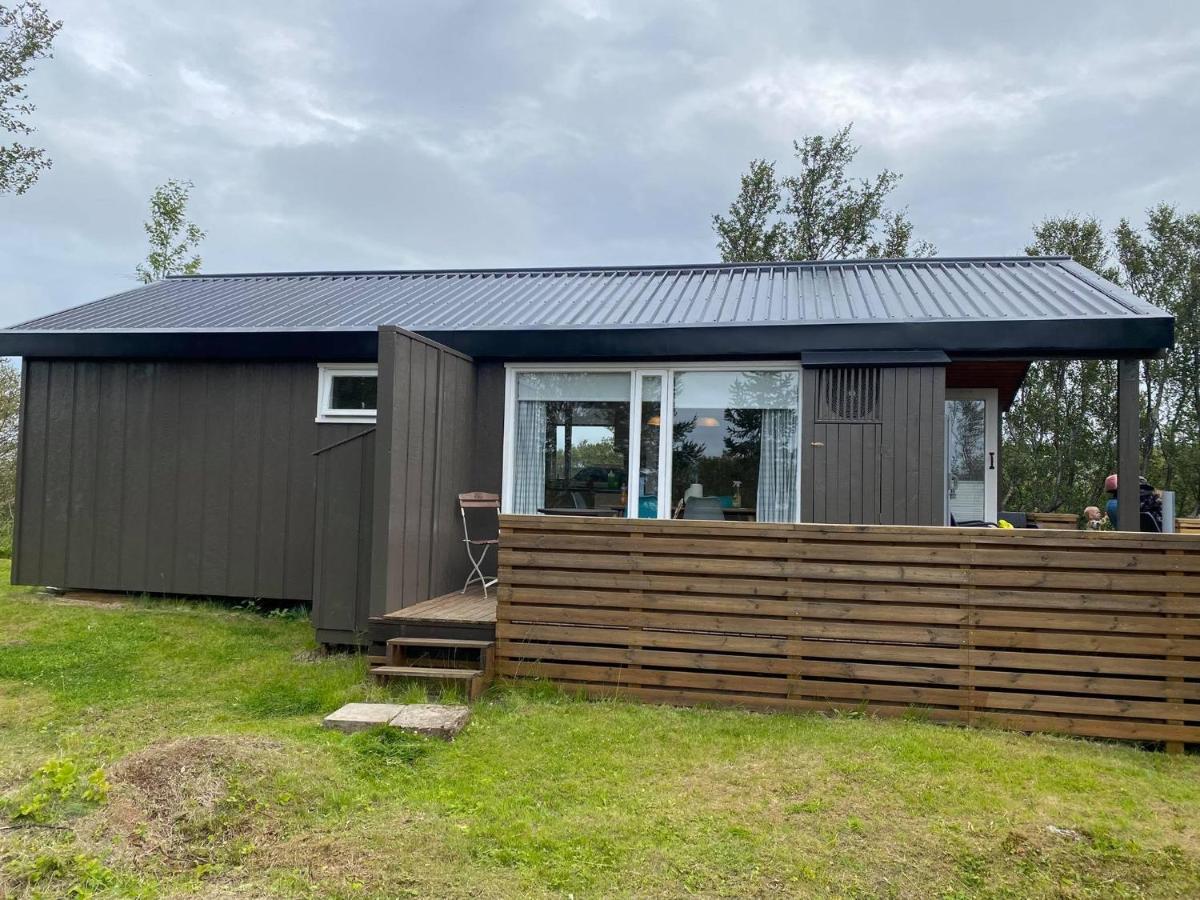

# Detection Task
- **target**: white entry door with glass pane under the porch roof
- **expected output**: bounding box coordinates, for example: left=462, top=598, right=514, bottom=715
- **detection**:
left=946, top=389, right=1000, bottom=524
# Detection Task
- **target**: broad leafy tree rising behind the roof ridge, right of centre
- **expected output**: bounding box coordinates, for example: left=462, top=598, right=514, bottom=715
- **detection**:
left=713, top=125, right=935, bottom=263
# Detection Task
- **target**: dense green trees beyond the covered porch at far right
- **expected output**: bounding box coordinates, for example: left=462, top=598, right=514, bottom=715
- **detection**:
left=1002, top=211, right=1200, bottom=515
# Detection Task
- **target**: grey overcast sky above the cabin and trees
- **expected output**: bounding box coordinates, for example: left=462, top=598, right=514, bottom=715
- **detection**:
left=0, top=0, right=1200, bottom=324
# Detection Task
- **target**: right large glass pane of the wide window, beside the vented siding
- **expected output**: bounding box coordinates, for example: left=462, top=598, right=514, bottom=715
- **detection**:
left=671, top=372, right=799, bottom=522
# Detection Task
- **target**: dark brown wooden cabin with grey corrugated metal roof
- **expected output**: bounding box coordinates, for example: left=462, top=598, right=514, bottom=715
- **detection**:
left=0, top=257, right=1174, bottom=644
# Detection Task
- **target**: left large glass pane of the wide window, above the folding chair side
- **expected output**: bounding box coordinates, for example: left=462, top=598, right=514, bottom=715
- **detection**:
left=512, top=372, right=630, bottom=515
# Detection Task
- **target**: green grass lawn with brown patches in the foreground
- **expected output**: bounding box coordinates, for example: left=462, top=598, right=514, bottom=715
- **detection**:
left=0, top=565, right=1200, bottom=898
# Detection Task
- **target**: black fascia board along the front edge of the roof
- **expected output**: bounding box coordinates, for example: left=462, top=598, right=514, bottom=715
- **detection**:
left=0, top=313, right=1175, bottom=360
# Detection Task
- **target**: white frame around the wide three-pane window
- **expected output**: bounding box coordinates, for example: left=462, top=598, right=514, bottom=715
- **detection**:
left=500, top=360, right=804, bottom=522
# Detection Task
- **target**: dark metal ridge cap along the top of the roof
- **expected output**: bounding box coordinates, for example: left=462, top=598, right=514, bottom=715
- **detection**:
left=166, top=254, right=1070, bottom=281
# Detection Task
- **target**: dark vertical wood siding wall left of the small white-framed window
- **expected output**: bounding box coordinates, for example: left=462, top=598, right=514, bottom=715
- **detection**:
left=13, top=359, right=350, bottom=601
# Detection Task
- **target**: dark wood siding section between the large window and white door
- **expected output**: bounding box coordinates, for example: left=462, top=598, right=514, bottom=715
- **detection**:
left=800, top=366, right=946, bottom=524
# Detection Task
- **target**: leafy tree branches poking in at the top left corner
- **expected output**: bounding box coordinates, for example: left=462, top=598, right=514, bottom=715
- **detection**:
left=0, top=0, right=62, bottom=194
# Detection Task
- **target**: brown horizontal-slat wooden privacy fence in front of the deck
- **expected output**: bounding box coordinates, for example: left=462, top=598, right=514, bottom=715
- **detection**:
left=497, top=516, right=1200, bottom=750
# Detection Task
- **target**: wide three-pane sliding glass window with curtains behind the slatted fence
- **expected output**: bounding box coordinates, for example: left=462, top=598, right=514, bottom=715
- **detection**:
left=505, top=365, right=799, bottom=522
